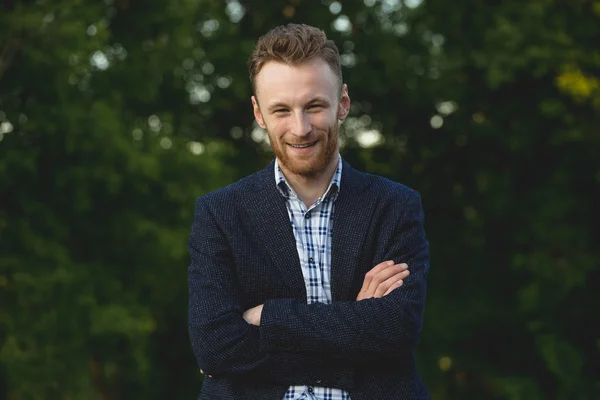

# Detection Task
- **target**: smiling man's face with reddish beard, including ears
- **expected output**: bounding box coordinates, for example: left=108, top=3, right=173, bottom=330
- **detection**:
left=252, top=58, right=350, bottom=178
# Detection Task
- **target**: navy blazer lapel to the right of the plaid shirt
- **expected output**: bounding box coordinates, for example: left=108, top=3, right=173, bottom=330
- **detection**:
left=331, top=161, right=376, bottom=301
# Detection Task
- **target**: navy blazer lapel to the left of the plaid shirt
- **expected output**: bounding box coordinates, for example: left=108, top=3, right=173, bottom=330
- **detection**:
left=242, top=161, right=306, bottom=301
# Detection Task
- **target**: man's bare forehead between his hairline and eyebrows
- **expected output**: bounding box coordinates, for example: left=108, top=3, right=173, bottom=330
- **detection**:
left=256, top=58, right=338, bottom=102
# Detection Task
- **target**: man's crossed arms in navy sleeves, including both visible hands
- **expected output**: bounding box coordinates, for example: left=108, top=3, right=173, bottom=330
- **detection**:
left=189, top=191, right=428, bottom=386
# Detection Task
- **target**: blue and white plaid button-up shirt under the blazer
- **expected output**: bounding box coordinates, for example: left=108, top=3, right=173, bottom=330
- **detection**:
left=275, top=155, right=350, bottom=400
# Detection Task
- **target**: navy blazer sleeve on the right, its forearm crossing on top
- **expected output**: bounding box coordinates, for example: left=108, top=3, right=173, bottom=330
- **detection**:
left=260, top=191, right=429, bottom=361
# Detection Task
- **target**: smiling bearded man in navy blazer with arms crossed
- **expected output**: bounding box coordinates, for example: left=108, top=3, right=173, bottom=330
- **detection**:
left=189, top=24, right=429, bottom=400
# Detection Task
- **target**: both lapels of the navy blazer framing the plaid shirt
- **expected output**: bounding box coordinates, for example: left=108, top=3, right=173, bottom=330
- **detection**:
left=242, top=159, right=373, bottom=301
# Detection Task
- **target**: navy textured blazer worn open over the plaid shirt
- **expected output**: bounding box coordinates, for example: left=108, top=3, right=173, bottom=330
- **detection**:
left=188, top=162, right=429, bottom=400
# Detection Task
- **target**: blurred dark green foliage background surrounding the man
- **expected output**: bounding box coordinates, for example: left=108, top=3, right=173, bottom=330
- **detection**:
left=0, top=0, right=600, bottom=400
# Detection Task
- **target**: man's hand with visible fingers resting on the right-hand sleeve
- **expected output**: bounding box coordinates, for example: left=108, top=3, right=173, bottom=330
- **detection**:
left=356, top=260, right=410, bottom=301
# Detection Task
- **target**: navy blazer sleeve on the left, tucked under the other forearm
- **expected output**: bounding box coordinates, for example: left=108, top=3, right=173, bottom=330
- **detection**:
left=188, top=198, right=353, bottom=388
